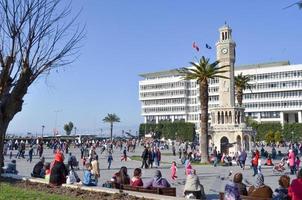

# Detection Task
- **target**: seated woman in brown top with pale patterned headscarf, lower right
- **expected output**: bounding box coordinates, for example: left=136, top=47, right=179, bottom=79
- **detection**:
left=248, top=174, right=273, bottom=198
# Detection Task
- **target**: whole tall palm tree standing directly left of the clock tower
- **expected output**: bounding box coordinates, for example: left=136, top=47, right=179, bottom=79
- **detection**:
left=179, top=56, right=227, bottom=163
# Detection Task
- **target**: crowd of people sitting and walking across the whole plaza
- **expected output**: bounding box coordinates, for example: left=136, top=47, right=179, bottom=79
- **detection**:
left=4, top=140, right=302, bottom=200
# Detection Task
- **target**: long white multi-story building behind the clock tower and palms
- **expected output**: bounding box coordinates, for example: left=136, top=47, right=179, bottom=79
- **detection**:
left=139, top=48, right=302, bottom=128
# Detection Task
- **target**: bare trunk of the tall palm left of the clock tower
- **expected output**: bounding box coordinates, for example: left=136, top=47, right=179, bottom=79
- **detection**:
left=199, top=80, right=209, bottom=163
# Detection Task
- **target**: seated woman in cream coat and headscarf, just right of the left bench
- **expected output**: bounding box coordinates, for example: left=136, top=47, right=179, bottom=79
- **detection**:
left=184, top=169, right=207, bottom=199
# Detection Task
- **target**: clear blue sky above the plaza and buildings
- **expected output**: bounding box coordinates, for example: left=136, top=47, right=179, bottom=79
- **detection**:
left=8, top=0, right=302, bottom=134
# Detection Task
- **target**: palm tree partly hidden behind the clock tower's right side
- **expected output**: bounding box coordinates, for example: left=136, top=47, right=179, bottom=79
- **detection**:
left=235, top=73, right=252, bottom=106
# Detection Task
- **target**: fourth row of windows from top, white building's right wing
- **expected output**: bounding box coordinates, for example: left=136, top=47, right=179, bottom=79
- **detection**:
left=243, top=100, right=302, bottom=109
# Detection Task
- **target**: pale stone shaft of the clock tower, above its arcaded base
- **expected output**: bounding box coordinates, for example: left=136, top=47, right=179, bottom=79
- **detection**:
left=216, top=24, right=236, bottom=107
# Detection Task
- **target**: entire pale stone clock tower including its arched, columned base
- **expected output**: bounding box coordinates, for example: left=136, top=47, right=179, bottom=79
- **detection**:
left=209, top=24, right=254, bottom=155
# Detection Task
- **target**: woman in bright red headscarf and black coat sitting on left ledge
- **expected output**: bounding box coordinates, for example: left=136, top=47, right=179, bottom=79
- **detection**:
left=49, top=152, right=68, bottom=186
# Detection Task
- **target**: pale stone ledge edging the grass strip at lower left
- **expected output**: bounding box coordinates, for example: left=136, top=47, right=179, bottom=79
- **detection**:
left=1, top=174, right=184, bottom=200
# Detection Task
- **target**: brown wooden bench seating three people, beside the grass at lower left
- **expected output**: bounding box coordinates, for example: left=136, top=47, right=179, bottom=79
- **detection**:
left=112, top=183, right=176, bottom=197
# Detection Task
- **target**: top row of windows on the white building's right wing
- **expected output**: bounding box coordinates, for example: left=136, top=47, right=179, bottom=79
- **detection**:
left=250, top=70, right=302, bottom=81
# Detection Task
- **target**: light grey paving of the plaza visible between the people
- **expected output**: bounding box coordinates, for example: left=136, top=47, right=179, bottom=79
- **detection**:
left=5, top=147, right=295, bottom=199
